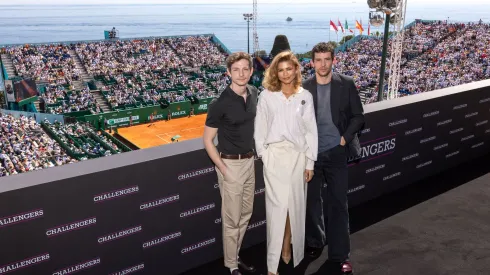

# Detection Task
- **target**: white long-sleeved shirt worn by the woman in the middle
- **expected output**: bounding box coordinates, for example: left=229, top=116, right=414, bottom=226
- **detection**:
left=254, top=88, right=318, bottom=170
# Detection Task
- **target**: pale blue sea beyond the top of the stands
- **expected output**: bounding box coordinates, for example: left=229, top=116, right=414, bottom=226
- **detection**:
left=0, top=0, right=490, bottom=53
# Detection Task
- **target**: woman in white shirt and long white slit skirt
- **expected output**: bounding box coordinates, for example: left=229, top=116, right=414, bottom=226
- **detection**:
left=254, top=51, right=318, bottom=275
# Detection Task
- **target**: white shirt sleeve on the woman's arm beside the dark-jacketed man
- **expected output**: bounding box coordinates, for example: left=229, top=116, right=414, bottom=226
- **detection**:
left=303, top=93, right=318, bottom=170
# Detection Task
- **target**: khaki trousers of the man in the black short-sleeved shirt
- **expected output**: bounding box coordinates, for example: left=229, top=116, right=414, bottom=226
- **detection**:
left=216, top=157, right=255, bottom=268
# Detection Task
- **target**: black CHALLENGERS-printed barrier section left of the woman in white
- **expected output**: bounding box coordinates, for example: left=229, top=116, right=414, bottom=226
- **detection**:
left=0, top=150, right=265, bottom=275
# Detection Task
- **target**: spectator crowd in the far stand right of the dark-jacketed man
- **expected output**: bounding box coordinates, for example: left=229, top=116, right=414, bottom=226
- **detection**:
left=334, top=21, right=490, bottom=103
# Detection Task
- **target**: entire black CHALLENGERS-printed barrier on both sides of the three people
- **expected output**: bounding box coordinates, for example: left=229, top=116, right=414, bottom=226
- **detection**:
left=0, top=89, right=490, bottom=275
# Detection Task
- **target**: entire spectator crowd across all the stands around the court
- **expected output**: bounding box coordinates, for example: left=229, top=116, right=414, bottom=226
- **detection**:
left=0, top=21, right=490, bottom=176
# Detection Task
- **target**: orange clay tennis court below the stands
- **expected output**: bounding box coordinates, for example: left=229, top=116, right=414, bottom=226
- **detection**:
left=118, top=114, right=207, bottom=149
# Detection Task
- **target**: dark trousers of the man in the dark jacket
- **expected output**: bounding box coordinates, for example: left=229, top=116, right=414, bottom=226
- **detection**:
left=305, top=145, right=350, bottom=261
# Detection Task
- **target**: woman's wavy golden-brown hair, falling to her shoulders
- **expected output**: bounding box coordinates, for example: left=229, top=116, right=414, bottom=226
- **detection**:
left=262, top=51, right=302, bottom=92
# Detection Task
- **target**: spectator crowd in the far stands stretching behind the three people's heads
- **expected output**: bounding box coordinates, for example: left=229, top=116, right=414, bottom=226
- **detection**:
left=1, top=21, right=490, bottom=110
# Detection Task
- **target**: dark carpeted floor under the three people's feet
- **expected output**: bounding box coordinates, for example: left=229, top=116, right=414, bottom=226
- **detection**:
left=184, top=155, right=490, bottom=275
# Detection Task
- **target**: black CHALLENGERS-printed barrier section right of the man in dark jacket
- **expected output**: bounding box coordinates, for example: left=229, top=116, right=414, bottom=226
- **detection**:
left=349, top=87, right=490, bottom=205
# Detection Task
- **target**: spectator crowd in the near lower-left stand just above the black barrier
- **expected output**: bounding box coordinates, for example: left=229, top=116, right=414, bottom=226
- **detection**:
left=0, top=113, right=129, bottom=177
